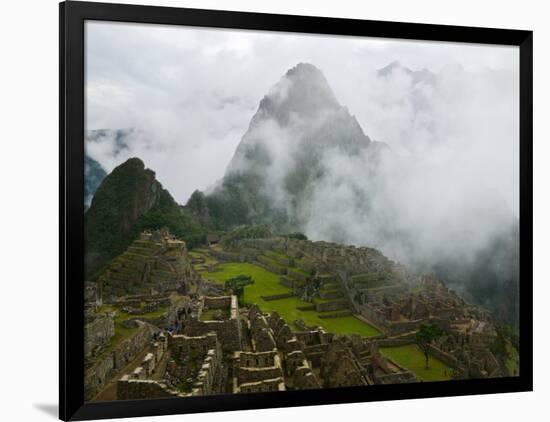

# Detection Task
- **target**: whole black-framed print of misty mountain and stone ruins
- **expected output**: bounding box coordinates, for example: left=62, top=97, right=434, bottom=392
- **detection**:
left=60, top=1, right=533, bottom=420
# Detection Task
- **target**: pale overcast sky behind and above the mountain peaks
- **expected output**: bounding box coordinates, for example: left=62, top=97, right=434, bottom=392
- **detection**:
left=86, top=22, right=519, bottom=211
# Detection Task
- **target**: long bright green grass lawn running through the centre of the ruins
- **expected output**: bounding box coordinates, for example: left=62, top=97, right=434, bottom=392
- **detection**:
left=208, top=263, right=380, bottom=337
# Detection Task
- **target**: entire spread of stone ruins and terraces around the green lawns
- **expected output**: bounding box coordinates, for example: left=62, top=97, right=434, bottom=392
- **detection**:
left=85, top=231, right=516, bottom=400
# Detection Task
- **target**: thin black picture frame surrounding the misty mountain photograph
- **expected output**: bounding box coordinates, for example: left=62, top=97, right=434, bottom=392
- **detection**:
left=59, top=1, right=533, bottom=420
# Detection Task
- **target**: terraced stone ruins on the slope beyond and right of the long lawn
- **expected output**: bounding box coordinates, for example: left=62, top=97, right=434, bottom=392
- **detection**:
left=212, top=237, right=507, bottom=378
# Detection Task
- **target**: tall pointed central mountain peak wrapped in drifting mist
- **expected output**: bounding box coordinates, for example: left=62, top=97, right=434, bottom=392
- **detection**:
left=208, top=63, right=384, bottom=230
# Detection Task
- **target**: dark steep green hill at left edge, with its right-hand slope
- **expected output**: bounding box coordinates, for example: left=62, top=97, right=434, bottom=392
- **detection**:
left=85, top=158, right=206, bottom=277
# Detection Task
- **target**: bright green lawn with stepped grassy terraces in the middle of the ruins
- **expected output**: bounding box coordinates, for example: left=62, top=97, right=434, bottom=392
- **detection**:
left=190, top=248, right=380, bottom=337
